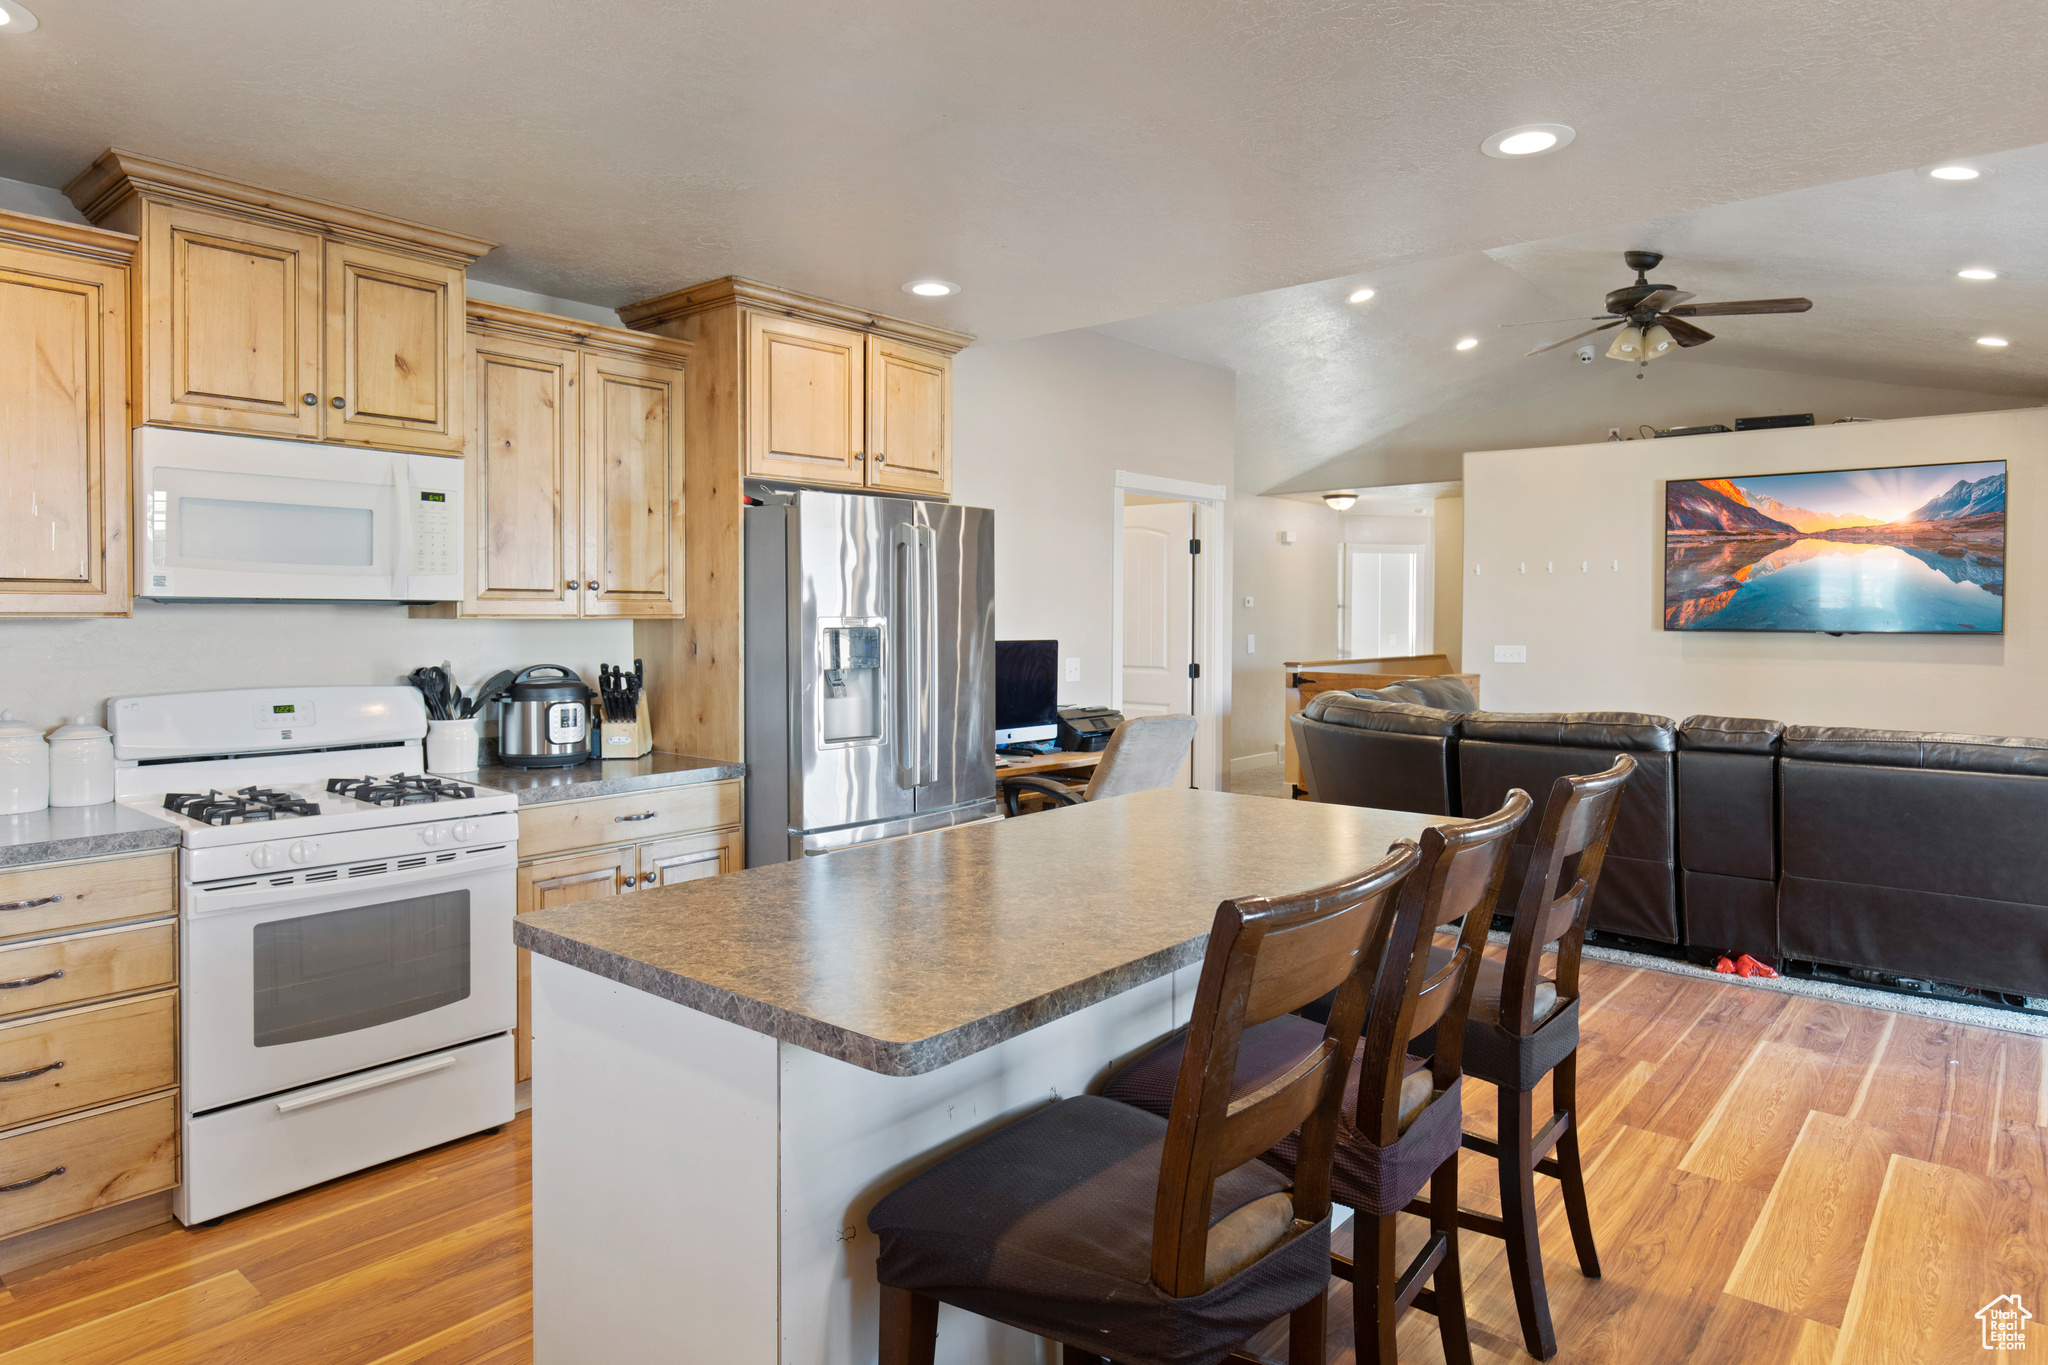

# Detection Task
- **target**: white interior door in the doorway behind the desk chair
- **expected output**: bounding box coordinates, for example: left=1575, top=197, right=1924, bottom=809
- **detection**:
left=1124, top=501, right=1194, bottom=784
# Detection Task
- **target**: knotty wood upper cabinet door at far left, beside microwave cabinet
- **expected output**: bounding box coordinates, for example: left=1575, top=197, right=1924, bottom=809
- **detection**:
left=0, top=248, right=129, bottom=616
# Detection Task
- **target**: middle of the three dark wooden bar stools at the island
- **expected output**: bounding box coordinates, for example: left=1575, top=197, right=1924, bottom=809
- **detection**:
left=1102, top=790, right=1530, bottom=1365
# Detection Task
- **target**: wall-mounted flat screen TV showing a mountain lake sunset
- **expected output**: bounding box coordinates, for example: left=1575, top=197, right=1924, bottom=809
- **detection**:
left=1665, top=460, right=2005, bottom=634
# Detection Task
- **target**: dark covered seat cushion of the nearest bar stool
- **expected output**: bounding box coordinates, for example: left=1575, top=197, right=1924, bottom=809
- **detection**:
left=868, top=1096, right=1329, bottom=1365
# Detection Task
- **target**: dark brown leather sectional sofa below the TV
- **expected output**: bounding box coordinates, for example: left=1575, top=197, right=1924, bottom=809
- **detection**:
left=1290, top=694, right=2048, bottom=997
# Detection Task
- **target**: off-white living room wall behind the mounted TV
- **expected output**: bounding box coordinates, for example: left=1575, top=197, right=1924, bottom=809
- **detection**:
left=1462, top=409, right=2048, bottom=735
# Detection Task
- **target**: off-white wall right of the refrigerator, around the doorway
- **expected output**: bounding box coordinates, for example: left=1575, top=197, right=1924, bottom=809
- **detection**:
left=952, top=332, right=1237, bottom=710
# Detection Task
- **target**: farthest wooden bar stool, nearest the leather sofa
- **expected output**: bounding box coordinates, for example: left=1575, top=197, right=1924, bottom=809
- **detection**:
left=1432, top=753, right=1636, bottom=1361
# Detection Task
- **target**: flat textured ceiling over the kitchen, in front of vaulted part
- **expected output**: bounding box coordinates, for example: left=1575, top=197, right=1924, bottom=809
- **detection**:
left=0, top=0, right=2048, bottom=340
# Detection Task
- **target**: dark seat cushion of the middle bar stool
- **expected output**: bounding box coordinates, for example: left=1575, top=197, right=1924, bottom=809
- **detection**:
left=1102, top=1015, right=1464, bottom=1216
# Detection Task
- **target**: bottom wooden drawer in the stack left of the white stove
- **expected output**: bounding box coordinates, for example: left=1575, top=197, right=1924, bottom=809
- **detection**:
left=0, top=1093, right=178, bottom=1236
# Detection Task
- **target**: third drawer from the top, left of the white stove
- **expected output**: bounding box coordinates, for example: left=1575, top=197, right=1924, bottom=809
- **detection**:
left=0, top=990, right=178, bottom=1128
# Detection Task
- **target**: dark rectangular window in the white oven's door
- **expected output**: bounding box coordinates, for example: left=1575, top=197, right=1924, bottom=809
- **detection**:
left=256, top=890, right=469, bottom=1048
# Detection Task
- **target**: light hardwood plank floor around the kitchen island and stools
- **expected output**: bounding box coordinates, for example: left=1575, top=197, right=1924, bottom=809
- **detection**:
left=0, top=962, right=2048, bottom=1365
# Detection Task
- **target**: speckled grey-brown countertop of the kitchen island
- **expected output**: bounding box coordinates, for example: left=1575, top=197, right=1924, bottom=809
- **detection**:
left=512, top=788, right=1442, bottom=1076
